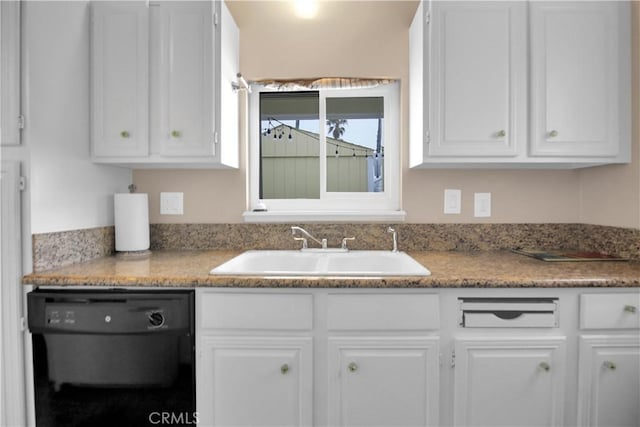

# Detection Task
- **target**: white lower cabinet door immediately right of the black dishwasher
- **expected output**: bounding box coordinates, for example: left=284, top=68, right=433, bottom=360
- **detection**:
left=196, top=336, right=313, bottom=426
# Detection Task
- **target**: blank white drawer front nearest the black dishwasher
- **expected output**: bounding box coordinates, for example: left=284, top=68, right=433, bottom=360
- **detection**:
left=197, top=293, right=313, bottom=330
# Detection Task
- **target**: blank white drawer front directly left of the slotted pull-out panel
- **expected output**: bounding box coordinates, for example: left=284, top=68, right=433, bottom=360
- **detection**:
left=327, top=294, right=440, bottom=330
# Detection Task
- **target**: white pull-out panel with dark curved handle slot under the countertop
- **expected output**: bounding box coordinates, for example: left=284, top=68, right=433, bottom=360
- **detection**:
left=458, top=297, right=559, bottom=328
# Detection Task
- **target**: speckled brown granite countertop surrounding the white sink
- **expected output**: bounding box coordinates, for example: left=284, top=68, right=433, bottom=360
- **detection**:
left=23, top=251, right=640, bottom=288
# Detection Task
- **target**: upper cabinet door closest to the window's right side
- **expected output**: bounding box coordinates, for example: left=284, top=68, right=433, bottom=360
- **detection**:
left=428, top=2, right=527, bottom=156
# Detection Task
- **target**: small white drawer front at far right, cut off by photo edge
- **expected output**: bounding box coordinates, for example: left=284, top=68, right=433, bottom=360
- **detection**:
left=580, top=292, right=640, bottom=329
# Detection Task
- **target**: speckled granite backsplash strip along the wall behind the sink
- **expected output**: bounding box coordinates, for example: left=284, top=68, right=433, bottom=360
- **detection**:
left=33, top=224, right=640, bottom=272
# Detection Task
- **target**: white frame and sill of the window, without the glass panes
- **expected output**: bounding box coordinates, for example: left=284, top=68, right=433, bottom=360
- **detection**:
left=244, top=82, right=405, bottom=222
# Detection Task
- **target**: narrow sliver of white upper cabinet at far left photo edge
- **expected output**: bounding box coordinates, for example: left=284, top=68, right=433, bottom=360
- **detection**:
left=0, top=0, right=22, bottom=146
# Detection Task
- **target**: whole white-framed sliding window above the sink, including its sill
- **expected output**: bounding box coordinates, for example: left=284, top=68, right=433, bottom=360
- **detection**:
left=244, top=82, right=404, bottom=222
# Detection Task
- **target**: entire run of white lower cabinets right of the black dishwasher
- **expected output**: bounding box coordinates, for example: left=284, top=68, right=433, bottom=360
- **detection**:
left=196, top=288, right=640, bottom=427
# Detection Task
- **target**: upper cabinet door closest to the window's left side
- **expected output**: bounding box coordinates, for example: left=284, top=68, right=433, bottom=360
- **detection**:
left=153, top=1, right=215, bottom=156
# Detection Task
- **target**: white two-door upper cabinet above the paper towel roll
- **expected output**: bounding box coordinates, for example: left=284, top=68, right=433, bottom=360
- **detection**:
left=92, top=1, right=239, bottom=168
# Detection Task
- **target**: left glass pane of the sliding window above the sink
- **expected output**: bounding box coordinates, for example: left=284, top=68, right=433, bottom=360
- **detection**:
left=260, top=92, right=320, bottom=199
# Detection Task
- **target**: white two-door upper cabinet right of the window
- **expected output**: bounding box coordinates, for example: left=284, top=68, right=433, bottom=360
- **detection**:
left=409, top=1, right=631, bottom=168
